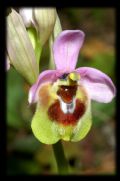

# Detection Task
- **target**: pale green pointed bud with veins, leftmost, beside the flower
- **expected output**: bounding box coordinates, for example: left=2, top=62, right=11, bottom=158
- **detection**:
left=7, top=9, right=39, bottom=84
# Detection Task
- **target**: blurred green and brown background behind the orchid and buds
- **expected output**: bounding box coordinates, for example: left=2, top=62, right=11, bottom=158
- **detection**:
left=7, top=8, right=116, bottom=175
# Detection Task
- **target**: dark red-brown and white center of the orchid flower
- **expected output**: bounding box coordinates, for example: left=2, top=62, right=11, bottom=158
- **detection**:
left=48, top=84, right=86, bottom=126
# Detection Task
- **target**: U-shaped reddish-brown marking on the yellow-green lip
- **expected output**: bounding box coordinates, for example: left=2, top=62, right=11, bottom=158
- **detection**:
left=48, top=99, right=85, bottom=126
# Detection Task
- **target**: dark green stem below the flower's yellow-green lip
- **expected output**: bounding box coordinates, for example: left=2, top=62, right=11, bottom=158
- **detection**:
left=53, top=141, right=69, bottom=175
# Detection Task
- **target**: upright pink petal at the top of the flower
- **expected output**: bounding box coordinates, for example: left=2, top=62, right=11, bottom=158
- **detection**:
left=53, top=30, right=85, bottom=72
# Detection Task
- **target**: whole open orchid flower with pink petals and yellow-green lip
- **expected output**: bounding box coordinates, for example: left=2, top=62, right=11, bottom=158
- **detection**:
left=28, top=30, right=116, bottom=144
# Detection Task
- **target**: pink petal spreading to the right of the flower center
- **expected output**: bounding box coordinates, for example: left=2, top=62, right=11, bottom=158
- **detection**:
left=76, top=67, right=116, bottom=103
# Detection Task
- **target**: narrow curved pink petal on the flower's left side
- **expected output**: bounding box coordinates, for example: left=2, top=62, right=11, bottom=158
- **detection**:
left=28, top=70, right=62, bottom=104
